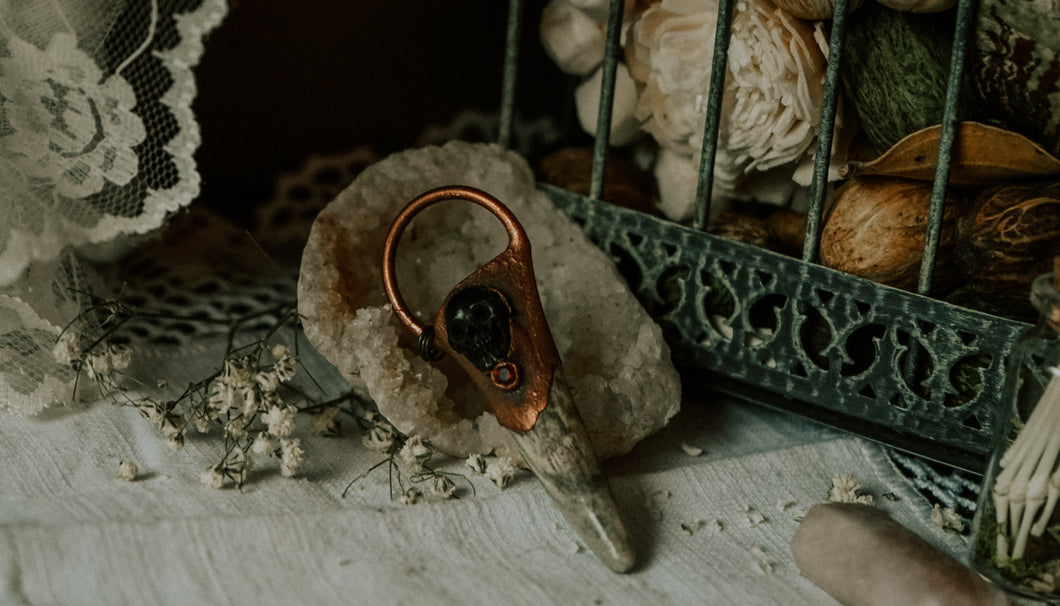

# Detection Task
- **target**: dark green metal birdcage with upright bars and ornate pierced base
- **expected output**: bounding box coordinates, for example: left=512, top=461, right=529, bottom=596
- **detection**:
left=499, top=0, right=1026, bottom=471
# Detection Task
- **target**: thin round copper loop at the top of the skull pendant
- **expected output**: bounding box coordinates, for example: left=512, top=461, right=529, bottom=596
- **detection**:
left=383, top=185, right=530, bottom=361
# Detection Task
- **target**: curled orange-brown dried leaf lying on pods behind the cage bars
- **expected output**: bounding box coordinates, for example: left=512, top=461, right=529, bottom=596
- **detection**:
left=840, top=122, right=1060, bottom=188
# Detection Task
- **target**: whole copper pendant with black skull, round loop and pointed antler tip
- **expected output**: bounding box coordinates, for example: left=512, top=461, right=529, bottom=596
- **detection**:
left=383, top=185, right=634, bottom=572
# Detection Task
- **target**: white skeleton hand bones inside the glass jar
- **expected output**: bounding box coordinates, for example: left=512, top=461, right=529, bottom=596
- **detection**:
left=991, top=367, right=1060, bottom=559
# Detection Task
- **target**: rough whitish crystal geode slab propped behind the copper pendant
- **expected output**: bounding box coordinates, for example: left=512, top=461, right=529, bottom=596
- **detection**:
left=298, top=142, right=681, bottom=458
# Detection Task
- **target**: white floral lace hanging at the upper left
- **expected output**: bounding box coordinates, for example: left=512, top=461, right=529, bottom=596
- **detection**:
left=0, top=0, right=227, bottom=413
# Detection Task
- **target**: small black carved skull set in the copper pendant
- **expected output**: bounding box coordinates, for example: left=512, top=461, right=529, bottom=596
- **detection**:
left=445, top=286, right=512, bottom=371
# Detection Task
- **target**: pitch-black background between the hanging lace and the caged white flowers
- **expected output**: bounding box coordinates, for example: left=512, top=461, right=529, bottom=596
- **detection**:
left=194, top=0, right=570, bottom=222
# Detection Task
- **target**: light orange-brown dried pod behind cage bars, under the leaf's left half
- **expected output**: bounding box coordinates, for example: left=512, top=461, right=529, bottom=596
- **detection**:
left=820, top=178, right=961, bottom=291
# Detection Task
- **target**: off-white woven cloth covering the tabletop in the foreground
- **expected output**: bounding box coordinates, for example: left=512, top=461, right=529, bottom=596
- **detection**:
left=0, top=336, right=965, bottom=605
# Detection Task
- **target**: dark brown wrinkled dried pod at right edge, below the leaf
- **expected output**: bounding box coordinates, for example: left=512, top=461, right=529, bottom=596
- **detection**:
left=956, top=183, right=1060, bottom=316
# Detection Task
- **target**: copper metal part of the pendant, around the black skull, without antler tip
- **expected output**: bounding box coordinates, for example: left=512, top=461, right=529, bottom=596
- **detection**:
left=383, top=185, right=560, bottom=431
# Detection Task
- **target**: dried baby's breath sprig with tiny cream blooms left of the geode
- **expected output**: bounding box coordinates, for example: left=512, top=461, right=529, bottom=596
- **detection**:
left=53, top=290, right=360, bottom=488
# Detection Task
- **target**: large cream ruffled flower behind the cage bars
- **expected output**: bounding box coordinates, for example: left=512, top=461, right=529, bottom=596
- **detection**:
left=625, top=0, right=827, bottom=199
